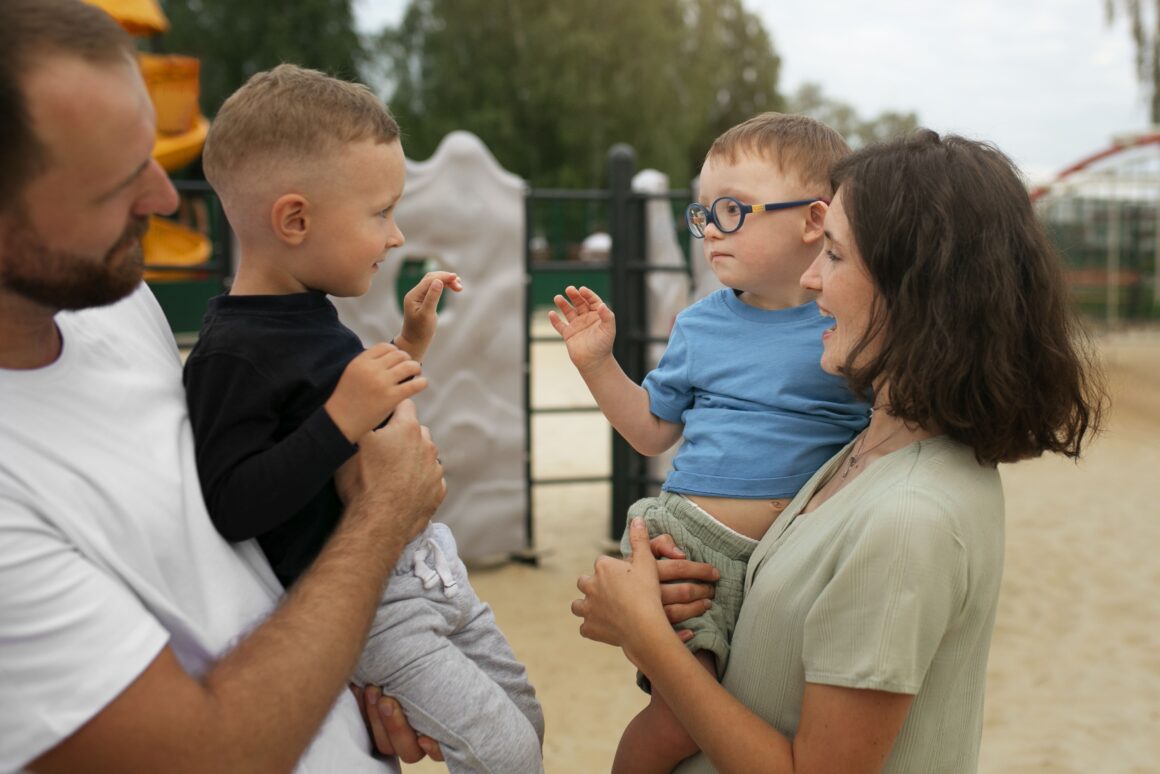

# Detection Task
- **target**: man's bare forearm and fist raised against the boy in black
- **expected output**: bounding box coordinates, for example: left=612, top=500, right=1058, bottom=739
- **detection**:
left=30, top=402, right=445, bottom=772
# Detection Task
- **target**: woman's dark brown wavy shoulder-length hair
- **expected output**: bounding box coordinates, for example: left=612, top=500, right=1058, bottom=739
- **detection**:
left=833, top=130, right=1107, bottom=464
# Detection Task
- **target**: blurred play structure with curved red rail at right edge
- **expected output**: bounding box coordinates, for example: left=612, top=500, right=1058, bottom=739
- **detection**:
left=1031, top=133, right=1160, bottom=326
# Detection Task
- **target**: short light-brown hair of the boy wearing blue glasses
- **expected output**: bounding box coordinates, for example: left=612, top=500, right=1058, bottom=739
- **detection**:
left=705, top=113, right=850, bottom=196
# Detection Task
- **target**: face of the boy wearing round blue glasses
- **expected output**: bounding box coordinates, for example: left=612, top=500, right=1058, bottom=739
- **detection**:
left=699, top=153, right=822, bottom=309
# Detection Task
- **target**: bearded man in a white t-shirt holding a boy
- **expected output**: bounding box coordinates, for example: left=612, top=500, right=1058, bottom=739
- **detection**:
left=0, top=0, right=445, bottom=772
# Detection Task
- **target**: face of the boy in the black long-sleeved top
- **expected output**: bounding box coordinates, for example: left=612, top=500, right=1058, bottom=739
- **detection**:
left=298, top=139, right=406, bottom=297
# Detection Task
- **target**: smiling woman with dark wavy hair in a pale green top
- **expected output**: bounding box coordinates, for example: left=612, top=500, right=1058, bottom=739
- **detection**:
left=572, top=131, right=1104, bottom=773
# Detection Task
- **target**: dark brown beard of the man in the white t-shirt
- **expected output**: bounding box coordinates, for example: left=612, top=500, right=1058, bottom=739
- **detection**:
left=0, top=216, right=148, bottom=310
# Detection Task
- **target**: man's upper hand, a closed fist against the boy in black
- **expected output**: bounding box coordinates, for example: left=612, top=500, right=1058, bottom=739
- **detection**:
left=334, top=400, right=447, bottom=545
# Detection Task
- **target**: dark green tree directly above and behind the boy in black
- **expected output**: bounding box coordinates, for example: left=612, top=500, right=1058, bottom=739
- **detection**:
left=154, top=0, right=365, bottom=115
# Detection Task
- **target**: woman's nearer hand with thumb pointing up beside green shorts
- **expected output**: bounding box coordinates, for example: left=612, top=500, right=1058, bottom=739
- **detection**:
left=572, top=519, right=672, bottom=666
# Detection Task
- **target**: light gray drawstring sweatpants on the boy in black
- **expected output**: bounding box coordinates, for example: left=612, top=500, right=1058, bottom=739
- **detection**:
left=355, top=522, right=544, bottom=774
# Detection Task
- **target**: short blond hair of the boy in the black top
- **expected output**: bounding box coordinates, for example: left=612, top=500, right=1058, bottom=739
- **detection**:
left=202, top=65, right=399, bottom=194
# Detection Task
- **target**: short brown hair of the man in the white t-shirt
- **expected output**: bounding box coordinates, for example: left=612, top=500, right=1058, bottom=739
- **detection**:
left=0, top=0, right=135, bottom=212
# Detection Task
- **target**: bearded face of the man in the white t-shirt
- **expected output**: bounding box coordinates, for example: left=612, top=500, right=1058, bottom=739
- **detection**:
left=0, top=57, right=176, bottom=310
